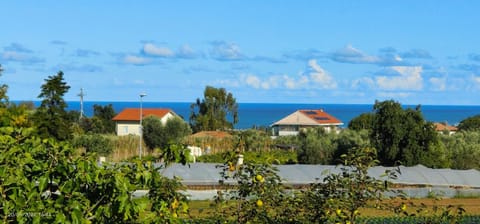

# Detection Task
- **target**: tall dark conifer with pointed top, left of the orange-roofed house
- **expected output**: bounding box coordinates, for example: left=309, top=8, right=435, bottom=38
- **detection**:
left=34, top=71, right=72, bottom=141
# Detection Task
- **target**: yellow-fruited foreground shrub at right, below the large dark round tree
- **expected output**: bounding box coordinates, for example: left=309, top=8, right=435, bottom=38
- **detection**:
left=303, top=148, right=398, bottom=223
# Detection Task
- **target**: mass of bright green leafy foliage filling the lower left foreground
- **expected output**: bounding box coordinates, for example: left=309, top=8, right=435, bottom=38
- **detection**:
left=0, top=97, right=188, bottom=223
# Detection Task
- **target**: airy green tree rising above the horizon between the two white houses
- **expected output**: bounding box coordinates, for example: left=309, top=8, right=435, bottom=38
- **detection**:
left=190, top=86, right=238, bottom=132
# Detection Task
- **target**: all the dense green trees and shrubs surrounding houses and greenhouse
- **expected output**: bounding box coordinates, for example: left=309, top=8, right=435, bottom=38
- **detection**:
left=0, top=66, right=480, bottom=223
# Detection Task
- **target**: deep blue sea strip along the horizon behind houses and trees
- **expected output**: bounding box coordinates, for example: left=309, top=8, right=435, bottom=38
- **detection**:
left=45, top=101, right=480, bottom=129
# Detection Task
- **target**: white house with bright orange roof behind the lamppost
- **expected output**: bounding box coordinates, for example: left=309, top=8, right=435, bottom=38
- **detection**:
left=112, top=108, right=179, bottom=136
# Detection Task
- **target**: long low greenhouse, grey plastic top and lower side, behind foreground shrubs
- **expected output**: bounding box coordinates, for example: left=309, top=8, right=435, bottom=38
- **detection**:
left=156, top=163, right=480, bottom=199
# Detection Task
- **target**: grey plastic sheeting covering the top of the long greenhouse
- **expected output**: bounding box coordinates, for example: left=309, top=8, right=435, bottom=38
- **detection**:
left=157, top=163, right=480, bottom=188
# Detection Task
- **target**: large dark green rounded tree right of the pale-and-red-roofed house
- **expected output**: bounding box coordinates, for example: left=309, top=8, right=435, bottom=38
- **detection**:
left=371, top=100, right=441, bottom=166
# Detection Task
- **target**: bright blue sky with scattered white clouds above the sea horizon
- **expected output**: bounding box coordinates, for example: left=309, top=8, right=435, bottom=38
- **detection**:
left=0, top=0, right=480, bottom=105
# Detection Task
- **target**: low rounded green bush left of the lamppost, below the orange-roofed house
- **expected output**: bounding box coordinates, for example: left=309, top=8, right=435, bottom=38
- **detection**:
left=72, top=134, right=113, bottom=156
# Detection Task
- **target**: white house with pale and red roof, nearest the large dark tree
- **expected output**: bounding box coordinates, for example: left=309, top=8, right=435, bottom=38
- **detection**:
left=271, top=109, right=343, bottom=136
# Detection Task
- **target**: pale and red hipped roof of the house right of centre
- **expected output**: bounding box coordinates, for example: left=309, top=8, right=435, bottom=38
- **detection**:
left=273, top=110, right=343, bottom=125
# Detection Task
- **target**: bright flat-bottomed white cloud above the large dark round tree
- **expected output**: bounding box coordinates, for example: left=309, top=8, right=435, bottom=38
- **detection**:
left=376, top=66, right=423, bottom=90
